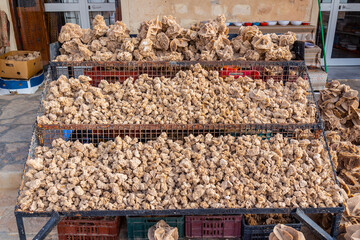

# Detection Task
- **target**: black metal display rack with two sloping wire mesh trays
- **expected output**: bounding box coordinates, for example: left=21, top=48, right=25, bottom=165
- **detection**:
left=15, top=61, right=344, bottom=240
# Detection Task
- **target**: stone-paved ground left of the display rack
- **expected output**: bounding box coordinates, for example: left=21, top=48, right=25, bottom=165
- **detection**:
left=0, top=89, right=57, bottom=240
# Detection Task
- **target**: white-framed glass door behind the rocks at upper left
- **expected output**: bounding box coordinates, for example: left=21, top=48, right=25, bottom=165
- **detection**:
left=44, top=0, right=117, bottom=43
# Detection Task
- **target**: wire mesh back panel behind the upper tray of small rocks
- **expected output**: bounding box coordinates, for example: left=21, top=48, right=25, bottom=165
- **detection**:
left=50, top=61, right=309, bottom=86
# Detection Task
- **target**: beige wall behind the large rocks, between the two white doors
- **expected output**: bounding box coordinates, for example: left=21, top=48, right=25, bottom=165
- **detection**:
left=121, top=0, right=317, bottom=33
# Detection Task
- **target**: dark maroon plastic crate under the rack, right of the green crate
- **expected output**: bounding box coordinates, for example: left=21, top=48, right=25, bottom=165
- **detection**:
left=185, top=215, right=242, bottom=238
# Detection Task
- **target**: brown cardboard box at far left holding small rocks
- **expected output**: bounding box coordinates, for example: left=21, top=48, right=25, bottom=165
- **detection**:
left=0, top=51, right=43, bottom=79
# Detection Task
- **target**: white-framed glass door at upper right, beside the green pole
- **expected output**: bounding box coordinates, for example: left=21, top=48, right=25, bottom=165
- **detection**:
left=317, top=0, right=360, bottom=66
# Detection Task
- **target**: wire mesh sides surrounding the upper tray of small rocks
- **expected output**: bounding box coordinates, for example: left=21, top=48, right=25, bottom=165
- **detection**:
left=38, top=61, right=321, bottom=145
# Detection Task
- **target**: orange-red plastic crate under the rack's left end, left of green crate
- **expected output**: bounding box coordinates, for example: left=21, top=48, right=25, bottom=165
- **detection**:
left=57, top=217, right=120, bottom=240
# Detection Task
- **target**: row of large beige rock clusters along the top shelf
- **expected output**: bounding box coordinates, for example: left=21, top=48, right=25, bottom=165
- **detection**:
left=56, top=15, right=296, bottom=62
